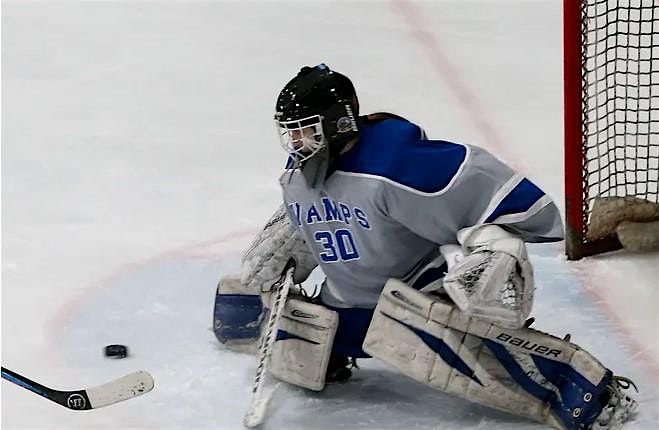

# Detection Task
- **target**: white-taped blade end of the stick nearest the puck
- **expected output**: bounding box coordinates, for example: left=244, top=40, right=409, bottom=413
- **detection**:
left=86, top=370, right=153, bottom=408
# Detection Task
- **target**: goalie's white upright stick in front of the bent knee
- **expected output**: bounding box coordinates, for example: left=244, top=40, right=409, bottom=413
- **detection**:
left=243, top=259, right=295, bottom=428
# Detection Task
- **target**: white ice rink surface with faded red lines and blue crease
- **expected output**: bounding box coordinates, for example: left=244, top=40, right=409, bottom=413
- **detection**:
left=1, top=0, right=659, bottom=430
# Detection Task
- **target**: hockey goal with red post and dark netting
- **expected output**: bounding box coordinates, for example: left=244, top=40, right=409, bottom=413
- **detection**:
left=563, top=0, right=659, bottom=259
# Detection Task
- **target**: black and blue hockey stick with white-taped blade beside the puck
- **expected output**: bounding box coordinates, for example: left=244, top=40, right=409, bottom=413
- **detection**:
left=2, top=367, right=153, bottom=411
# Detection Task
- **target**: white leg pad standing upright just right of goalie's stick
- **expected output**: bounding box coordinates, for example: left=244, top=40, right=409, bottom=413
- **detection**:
left=270, top=299, right=339, bottom=391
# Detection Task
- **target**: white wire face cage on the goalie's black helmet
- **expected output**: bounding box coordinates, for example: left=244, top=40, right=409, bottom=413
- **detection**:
left=275, top=115, right=327, bottom=163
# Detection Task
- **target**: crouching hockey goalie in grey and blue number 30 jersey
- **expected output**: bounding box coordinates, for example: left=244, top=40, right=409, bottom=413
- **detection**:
left=214, top=64, right=636, bottom=429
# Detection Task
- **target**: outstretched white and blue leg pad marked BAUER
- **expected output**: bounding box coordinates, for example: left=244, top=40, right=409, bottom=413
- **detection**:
left=364, top=279, right=628, bottom=429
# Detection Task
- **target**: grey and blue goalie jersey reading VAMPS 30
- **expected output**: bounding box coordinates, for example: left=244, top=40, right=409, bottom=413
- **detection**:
left=280, top=119, right=563, bottom=308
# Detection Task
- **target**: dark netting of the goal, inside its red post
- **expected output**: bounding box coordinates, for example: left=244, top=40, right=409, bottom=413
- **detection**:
left=582, top=0, right=659, bottom=235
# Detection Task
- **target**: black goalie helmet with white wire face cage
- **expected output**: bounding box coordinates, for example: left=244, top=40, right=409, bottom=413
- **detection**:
left=275, top=64, right=359, bottom=163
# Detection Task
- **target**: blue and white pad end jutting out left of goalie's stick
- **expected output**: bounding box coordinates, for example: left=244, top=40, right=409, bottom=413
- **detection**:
left=213, top=275, right=264, bottom=353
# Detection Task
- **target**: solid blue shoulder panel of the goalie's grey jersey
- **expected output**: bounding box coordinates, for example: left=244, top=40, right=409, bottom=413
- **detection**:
left=335, top=119, right=467, bottom=193
